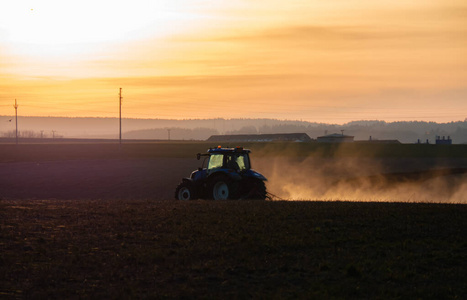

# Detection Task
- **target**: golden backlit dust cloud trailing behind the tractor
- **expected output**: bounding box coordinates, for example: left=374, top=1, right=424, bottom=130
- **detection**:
left=254, top=146, right=467, bottom=204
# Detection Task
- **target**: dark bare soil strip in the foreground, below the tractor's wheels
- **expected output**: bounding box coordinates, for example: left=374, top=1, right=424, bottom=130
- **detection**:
left=0, top=199, right=467, bottom=299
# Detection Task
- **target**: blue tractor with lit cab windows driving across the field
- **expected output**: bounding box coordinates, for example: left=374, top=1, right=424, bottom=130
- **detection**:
left=175, top=146, right=267, bottom=200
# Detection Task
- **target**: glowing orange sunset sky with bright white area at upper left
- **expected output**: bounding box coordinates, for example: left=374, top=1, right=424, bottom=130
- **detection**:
left=0, top=0, right=467, bottom=123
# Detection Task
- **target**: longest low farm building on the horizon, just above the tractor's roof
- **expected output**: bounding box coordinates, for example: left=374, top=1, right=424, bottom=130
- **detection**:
left=207, top=133, right=311, bottom=142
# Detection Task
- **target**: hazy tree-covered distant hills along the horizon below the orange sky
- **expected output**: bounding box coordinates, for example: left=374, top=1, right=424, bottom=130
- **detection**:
left=0, top=116, right=467, bottom=144
